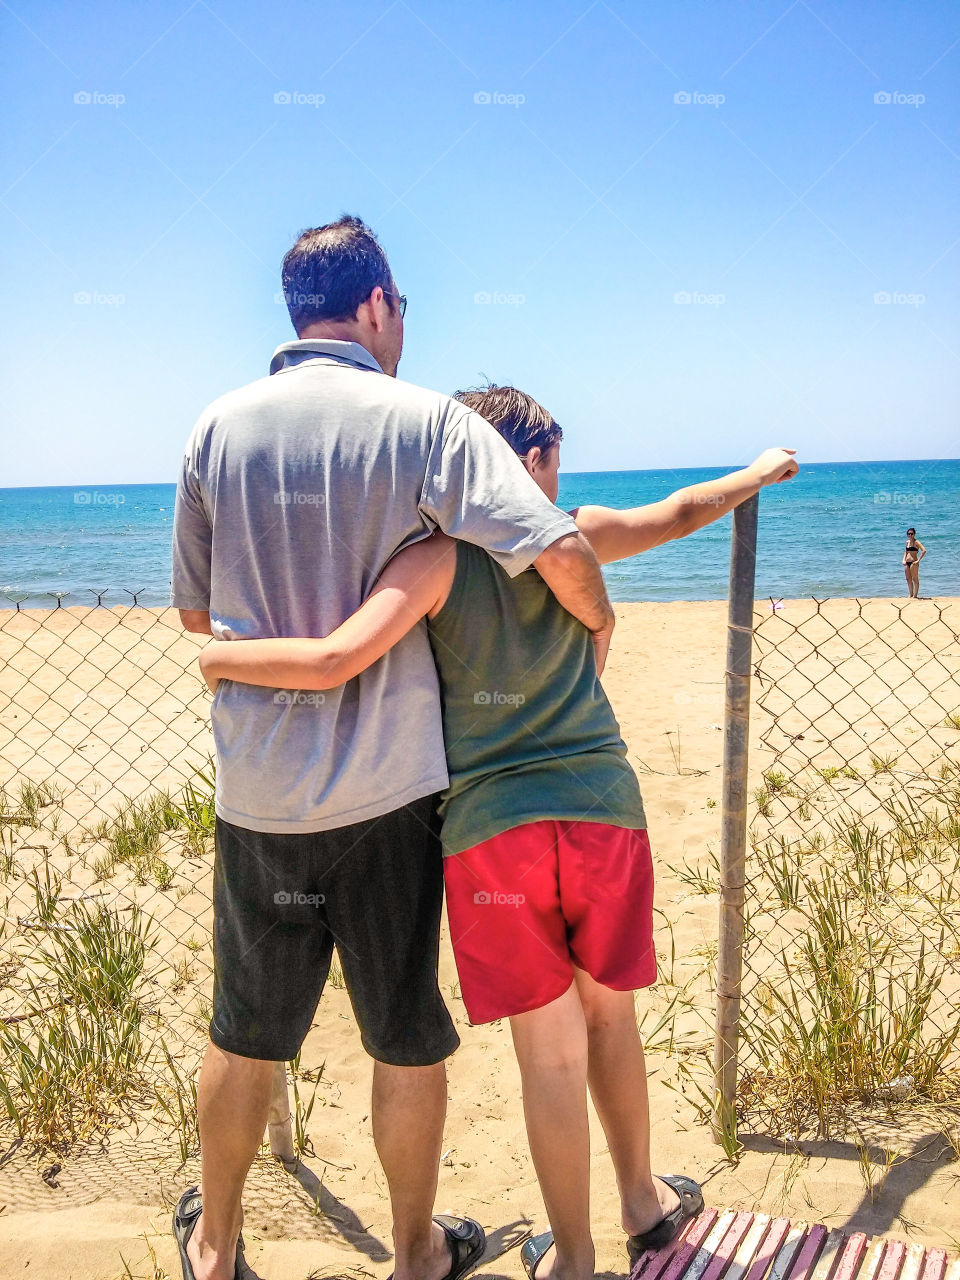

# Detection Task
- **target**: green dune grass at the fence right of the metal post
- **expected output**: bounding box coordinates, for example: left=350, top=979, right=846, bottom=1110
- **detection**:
left=739, top=760, right=960, bottom=1137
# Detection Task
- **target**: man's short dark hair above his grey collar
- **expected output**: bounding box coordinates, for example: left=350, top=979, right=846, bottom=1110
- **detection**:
left=280, top=214, right=394, bottom=333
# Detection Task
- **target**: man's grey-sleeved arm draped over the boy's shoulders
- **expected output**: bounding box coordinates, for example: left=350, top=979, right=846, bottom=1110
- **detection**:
left=420, top=401, right=613, bottom=659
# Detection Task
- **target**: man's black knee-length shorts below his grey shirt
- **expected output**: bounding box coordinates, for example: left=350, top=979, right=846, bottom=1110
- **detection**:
left=210, top=796, right=460, bottom=1066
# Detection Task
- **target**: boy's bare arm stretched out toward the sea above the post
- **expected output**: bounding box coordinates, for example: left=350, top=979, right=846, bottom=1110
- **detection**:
left=571, top=449, right=799, bottom=564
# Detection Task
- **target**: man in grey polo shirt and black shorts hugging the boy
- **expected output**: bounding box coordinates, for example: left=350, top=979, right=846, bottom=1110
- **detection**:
left=173, top=216, right=613, bottom=1280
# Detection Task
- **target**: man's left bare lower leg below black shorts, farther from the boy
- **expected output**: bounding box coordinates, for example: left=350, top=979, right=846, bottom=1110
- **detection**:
left=187, top=1042, right=274, bottom=1280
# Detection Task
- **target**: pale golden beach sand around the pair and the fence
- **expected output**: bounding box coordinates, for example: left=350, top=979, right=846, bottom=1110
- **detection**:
left=0, top=600, right=960, bottom=1280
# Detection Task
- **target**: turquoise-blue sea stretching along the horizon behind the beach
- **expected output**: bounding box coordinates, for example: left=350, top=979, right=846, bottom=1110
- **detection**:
left=0, top=458, right=960, bottom=608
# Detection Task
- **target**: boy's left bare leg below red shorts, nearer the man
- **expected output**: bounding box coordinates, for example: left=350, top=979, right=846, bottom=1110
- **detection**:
left=509, top=983, right=594, bottom=1280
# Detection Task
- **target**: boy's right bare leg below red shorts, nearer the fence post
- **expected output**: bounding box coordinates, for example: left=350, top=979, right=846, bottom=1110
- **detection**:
left=575, top=969, right=680, bottom=1235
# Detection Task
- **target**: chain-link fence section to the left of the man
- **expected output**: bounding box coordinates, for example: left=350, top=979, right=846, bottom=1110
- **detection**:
left=0, top=598, right=212, bottom=1172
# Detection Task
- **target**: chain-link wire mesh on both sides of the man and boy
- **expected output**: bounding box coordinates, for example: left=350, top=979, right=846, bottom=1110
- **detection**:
left=0, top=599, right=960, bottom=1212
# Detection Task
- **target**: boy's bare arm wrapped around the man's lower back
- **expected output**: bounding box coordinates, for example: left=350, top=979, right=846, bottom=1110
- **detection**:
left=200, top=534, right=457, bottom=690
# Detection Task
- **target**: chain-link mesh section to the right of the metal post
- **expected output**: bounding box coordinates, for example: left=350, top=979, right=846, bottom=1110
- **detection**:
left=737, top=600, right=960, bottom=1137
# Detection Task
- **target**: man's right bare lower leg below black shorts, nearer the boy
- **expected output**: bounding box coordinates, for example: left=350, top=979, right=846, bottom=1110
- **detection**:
left=371, top=1062, right=452, bottom=1280
